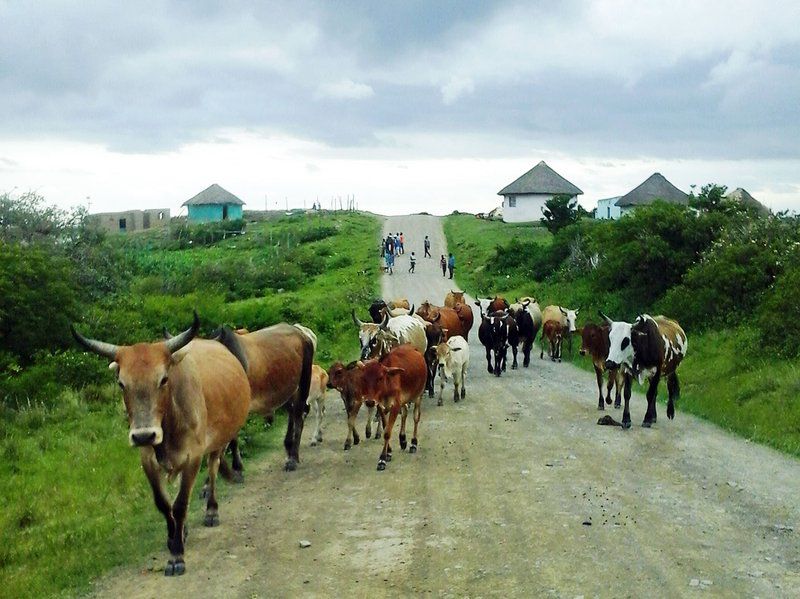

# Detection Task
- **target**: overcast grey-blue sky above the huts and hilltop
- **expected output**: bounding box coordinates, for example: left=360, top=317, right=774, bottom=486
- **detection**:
left=0, top=0, right=800, bottom=214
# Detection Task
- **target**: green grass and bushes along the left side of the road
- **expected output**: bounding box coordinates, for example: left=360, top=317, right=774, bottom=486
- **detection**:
left=0, top=196, right=380, bottom=596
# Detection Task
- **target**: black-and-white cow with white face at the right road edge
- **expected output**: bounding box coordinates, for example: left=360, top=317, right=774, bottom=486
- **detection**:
left=600, top=312, right=688, bottom=428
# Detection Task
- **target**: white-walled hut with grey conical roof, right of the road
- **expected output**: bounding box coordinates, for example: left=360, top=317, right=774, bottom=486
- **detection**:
left=497, top=160, right=583, bottom=223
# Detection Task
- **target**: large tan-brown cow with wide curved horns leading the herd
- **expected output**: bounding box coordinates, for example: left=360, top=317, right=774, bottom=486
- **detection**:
left=72, top=314, right=250, bottom=576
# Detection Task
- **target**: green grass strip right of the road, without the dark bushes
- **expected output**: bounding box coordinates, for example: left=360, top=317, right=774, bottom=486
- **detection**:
left=444, top=215, right=800, bottom=457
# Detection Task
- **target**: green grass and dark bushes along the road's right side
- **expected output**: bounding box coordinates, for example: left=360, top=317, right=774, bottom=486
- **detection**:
left=445, top=199, right=800, bottom=456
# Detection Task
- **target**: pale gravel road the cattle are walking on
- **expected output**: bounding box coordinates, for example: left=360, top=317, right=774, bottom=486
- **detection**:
left=96, top=216, right=800, bottom=598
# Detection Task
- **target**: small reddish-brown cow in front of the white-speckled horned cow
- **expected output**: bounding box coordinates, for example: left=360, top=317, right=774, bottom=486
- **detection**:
left=359, top=345, right=428, bottom=470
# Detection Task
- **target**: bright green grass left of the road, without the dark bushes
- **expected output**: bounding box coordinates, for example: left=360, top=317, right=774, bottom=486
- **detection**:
left=0, top=214, right=381, bottom=597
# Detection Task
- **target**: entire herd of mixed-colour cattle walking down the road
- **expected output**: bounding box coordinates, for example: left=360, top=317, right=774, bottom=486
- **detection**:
left=72, top=291, right=687, bottom=576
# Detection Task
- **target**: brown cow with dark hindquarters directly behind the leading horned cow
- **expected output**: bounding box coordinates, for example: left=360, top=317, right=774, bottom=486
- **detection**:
left=219, top=323, right=314, bottom=470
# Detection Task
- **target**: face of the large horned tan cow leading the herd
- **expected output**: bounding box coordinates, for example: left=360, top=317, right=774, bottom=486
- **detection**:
left=110, top=343, right=174, bottom=447
